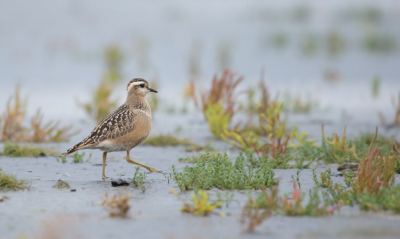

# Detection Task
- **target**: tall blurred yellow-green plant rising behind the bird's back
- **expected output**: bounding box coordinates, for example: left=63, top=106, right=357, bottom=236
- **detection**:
left=79, top=46, right=123, bottom=122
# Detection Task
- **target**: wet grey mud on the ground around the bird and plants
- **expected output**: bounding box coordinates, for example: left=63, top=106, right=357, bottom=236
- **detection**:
left=0, top=116, right=400, bottom=239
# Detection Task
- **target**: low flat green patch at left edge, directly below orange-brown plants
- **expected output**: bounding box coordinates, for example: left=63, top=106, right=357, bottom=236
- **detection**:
left=0, top=142, right=55, bottom=158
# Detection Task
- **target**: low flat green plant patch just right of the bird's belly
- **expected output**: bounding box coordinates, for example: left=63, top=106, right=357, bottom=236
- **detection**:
left=143, top=134, right=214, bottom=151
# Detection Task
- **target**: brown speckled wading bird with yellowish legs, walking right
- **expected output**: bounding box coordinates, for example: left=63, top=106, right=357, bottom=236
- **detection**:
left=62, top=78, right=161, bottom=179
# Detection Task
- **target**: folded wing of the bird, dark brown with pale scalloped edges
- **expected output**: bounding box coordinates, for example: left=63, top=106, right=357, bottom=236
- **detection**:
left=63, top=104, right=137, bottom=155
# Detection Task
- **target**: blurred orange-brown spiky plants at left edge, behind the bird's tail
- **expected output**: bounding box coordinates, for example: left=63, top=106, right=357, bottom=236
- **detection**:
left=0, top=87, right=78, bottom=143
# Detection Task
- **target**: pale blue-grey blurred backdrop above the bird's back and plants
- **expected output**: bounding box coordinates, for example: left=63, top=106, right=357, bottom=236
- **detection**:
left=0, top=0, right=400, bottom=127
